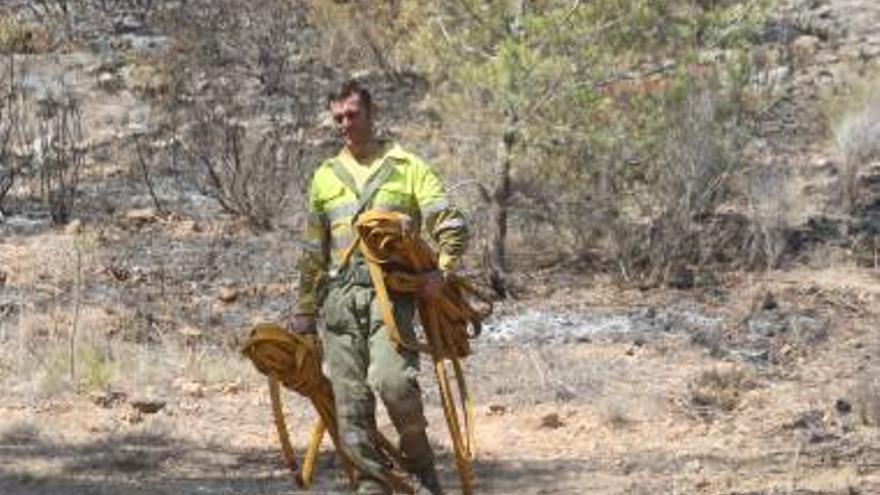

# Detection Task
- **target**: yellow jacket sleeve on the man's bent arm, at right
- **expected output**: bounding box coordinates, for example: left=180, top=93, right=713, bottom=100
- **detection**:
left=415, top=160, right=468, bottom=272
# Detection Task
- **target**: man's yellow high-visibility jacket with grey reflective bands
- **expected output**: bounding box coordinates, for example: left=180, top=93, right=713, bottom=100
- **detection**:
left=296, top=142, right=468, bottom=315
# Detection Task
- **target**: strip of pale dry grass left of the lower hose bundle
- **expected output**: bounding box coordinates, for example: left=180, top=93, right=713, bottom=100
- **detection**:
left=0, top=298, right=256, bottom=398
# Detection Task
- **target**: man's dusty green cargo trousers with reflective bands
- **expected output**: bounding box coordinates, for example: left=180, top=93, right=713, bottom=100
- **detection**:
left=320, top=284, right=434, bottom=494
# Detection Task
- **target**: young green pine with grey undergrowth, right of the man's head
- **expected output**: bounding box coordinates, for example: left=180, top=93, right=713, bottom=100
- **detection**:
left=313, top=0, right=765, bottom=288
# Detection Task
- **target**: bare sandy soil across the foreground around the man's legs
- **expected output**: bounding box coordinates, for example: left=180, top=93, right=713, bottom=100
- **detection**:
left=0, top=269, right=880, bottom=495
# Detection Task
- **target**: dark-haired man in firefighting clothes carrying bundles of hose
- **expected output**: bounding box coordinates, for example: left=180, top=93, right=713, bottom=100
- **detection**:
left=291, top=81, right=467, bottom=495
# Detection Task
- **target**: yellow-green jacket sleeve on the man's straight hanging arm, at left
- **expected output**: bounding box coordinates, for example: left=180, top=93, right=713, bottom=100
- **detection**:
left=296, top=175, right=330, bottom=315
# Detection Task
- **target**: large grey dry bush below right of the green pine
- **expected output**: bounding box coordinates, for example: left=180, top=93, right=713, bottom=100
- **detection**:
left=602, top=83, right=742, bottom=283
